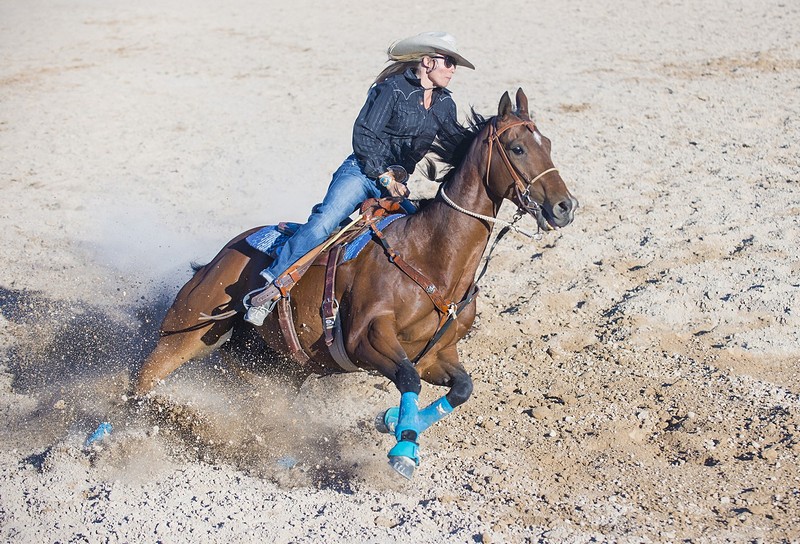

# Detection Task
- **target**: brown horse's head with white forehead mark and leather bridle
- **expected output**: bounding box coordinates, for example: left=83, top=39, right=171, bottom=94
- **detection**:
left=487, top=89, right=578, bottom=230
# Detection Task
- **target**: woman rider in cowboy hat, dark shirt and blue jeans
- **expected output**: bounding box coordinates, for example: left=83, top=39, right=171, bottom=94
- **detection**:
left=244, top=32, right=468, bottom=326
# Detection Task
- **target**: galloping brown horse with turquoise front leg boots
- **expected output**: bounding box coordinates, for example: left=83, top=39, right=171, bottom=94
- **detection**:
left=135, top=89, right=578, bottom=478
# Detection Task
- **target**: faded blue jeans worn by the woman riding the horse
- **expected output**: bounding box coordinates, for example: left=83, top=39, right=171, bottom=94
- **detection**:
left=261, top=155, right=381, bottom=282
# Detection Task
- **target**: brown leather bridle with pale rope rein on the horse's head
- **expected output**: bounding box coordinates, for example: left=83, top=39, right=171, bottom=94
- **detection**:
left=440, top=118, right=558, bottom=238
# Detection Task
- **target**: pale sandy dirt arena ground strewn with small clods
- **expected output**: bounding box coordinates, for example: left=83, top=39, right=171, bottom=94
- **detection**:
left=0, top=0, right=800, bottom=543
